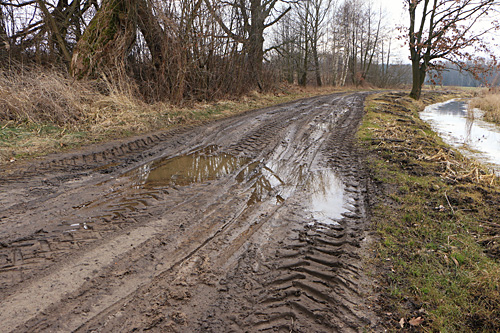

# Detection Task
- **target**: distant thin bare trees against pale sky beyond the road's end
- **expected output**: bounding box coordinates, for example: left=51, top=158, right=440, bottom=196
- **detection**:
left=270, top=0, right=410, bottom=87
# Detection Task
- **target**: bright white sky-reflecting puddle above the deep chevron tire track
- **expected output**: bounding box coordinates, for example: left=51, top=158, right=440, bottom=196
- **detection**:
left=307, top=170, right=348, bottom=225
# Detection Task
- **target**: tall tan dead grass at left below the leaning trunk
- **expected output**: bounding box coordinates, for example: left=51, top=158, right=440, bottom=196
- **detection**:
left=0, top=67, right=172, bottom=133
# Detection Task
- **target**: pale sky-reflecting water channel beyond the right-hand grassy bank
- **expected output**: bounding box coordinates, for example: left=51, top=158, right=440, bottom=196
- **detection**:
left=420, top=100, right=500, bottom=175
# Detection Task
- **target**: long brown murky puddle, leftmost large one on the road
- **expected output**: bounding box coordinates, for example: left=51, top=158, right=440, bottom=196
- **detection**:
left=126, top=146, right=249, bottom=187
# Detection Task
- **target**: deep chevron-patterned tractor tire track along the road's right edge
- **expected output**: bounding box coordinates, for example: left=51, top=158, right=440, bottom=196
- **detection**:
left=191, top=92, right=373, bottom=332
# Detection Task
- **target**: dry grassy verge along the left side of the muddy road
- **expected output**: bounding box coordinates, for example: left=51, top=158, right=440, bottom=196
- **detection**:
left=0, top=68, right=350, bottom=164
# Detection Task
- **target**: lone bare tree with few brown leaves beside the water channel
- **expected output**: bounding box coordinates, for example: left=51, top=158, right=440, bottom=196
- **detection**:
left=405, top=0, right=499, bottom=99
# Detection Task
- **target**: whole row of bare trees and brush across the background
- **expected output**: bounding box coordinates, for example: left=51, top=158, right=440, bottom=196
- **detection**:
left=0, top=0, right=495, bottom=103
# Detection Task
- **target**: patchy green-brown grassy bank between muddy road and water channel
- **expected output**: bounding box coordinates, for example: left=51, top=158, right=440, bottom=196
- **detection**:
left=358, top=92, right=500, bottom=332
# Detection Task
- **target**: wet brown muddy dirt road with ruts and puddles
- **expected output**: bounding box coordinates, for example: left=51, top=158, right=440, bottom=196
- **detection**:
left=0, top=93, right=377, bottom=332
